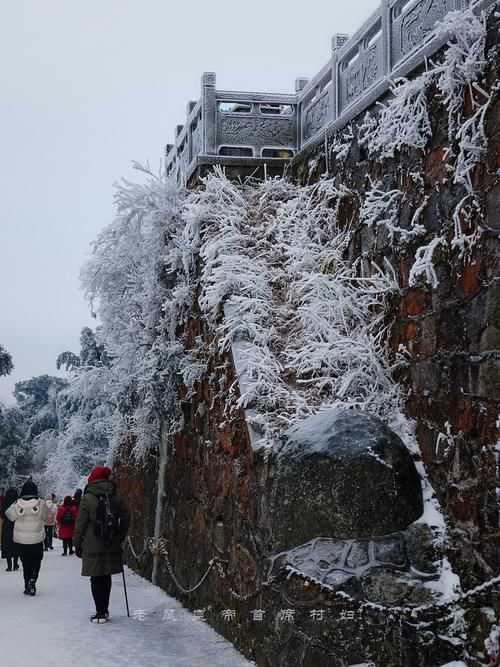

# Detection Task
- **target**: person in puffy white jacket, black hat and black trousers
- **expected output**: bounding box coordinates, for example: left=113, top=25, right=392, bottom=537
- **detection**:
left=5, top=479, right=49, bottom=595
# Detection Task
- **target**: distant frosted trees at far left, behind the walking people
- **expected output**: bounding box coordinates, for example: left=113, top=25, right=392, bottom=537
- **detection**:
left=0, top=327, right=108, bottom=493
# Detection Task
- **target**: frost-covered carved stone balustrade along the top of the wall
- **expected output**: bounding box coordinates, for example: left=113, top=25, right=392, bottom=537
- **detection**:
left=165, top=0, right=494, bottom=185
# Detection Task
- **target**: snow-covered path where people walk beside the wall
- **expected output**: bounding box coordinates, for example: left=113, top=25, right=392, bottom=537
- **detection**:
left=0, top=540, right=254, bottom=667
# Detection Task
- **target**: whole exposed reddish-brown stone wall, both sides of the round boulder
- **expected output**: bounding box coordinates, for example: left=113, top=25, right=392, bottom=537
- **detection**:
left=114, top=11, right=500, bottom=667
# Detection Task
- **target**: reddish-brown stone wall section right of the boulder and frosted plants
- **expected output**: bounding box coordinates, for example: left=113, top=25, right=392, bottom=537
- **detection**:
left=295, top=18, right=500, bottom=584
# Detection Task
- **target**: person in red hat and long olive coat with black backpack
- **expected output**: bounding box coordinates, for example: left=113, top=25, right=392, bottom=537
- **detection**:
left=73, top=466, right=129, bottom=623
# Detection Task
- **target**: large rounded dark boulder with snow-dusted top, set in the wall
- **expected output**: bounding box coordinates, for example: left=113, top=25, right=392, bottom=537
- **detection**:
left=268, top=409, right=423, bottom=553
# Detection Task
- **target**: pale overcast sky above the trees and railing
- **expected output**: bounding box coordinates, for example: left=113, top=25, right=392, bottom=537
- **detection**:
left=0, top=0, right=380, bottom=404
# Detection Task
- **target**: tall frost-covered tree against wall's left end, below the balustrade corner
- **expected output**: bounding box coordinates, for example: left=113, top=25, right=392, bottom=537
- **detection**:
left=82, top=164, right=193, bottom=456
